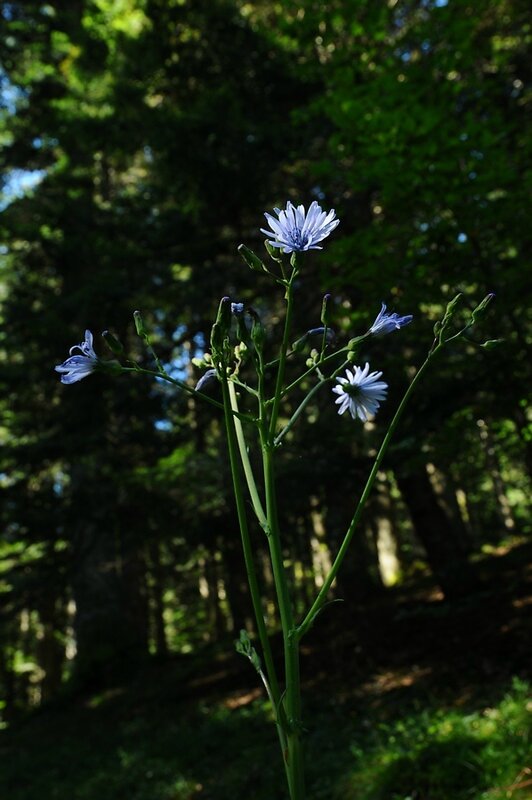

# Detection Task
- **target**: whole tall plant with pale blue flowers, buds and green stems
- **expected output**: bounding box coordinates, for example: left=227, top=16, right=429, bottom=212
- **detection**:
left=56, top=202, right=493, bottom=800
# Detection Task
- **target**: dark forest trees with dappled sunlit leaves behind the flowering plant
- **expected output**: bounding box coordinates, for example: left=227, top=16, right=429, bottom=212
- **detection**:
left=0, top=0, right=531, bottom=800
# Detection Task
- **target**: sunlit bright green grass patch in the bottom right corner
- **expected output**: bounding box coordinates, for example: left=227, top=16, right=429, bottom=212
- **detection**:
left=338, top=679, right=532, bottom=800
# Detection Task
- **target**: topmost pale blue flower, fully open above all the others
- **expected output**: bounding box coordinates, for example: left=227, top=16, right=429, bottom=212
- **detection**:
left=260, top=200, right=340, bottom=253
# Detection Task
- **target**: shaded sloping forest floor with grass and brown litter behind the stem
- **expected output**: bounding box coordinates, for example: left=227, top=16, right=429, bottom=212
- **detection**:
left=0, top=545, right=532, bottom=800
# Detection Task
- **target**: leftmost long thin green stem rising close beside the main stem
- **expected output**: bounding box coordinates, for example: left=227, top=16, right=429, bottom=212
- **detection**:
left=222, top=377, right=288, bottom=752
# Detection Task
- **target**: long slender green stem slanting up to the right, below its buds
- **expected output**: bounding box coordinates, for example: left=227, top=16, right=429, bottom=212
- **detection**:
left=297, top=345, right=441, bottom=637
